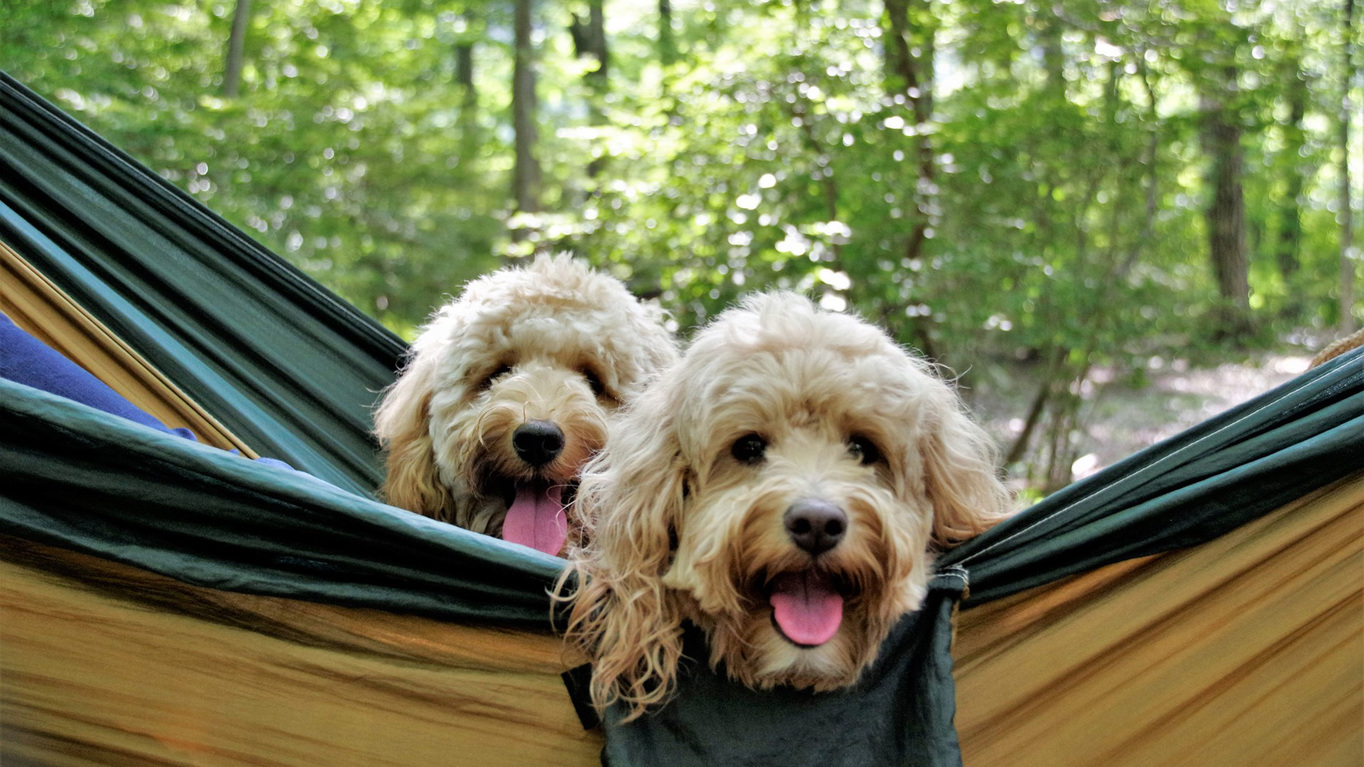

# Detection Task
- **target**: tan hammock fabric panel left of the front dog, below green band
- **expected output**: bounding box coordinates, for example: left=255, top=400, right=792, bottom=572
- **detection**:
left=0, top=536, right=600, bottom=767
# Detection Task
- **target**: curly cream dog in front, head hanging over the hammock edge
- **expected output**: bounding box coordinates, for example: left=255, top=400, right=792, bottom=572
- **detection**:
left=569, top=293, right=1009, bottom=721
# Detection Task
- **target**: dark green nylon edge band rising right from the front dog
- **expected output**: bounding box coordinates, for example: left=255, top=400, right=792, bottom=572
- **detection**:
left=941, top=351, right=1364, bottom=600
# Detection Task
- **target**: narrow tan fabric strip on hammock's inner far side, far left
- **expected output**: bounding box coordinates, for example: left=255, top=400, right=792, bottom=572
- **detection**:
left=0, top=242, right=256, bottom=459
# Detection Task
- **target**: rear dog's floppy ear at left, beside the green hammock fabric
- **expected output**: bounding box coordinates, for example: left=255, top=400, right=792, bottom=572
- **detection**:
left=374, top=353, right=454, bottom=521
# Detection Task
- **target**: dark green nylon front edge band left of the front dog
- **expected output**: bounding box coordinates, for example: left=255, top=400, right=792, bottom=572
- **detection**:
left=0, top=379, right=563, bottom=632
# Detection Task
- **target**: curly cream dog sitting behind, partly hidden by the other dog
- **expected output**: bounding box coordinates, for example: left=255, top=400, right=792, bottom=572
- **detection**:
left=374, top=255, right=677, bottom=554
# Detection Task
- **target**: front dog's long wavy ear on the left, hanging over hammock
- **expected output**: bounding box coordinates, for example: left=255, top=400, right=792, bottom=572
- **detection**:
left=567, top=384, right=687, bottom=721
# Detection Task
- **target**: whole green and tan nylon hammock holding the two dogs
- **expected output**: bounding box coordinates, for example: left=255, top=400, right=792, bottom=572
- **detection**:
left=0, top=75, right=1364, bottom=767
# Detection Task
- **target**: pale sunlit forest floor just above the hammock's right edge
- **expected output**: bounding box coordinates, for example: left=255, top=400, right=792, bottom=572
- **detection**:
left=967, top=351, right=1311, bottom=487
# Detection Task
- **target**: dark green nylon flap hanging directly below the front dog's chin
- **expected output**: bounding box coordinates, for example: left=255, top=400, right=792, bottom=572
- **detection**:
left=602, top=570, right=964, bottom=767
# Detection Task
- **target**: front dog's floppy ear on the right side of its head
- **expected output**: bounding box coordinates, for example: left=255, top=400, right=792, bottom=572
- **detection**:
left=919, top=382, right=1011, bottom=547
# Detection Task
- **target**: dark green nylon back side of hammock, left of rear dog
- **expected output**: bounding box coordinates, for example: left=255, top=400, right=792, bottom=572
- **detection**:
left=0, top=74, right=405, bottom=493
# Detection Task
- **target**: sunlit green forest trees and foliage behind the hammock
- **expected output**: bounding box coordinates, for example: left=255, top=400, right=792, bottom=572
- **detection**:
left=0, top=0, right=1364, bottom=493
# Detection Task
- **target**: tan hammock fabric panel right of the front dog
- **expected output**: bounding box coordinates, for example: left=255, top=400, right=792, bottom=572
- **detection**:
left=953, top=475, right=1364, bottom=767
